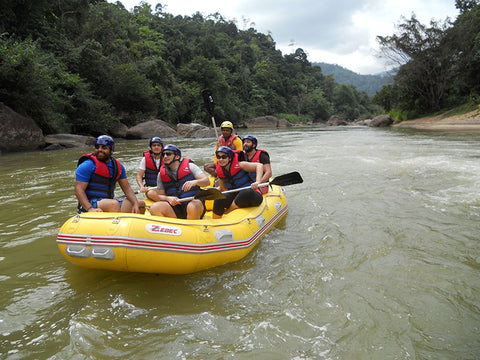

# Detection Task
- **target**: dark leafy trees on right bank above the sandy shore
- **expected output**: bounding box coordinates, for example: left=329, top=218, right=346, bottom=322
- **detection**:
left=373, top=0, right=480, bottom=120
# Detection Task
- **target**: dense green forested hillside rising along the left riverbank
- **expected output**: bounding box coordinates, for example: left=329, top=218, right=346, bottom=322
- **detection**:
left=0, top=0, right=380, bottom=135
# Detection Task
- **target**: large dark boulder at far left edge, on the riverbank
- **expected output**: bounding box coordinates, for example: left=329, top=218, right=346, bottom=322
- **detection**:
left=0, top=102, right=45, bottom=152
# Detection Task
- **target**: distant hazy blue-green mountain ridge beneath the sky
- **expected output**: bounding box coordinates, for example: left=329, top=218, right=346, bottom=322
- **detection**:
left=312, top=62, right=393, bottom=96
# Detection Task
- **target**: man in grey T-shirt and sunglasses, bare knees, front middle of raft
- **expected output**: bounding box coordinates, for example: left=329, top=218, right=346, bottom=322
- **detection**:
left=150, top=144, right=210, bottom=220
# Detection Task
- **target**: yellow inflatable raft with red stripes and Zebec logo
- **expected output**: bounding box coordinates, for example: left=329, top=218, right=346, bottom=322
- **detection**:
left=57, top=185, right=288, bottom=274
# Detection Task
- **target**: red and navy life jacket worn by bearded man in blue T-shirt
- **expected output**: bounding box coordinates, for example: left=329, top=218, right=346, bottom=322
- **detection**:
left=77, top=153, right=122, bottom=200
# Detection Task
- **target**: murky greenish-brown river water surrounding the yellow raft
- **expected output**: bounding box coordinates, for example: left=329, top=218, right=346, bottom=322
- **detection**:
left=0, top=127, right=480, bottom=360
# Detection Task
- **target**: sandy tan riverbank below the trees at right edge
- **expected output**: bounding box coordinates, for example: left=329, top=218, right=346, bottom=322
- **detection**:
left=392, top=109, right=480, bottom=131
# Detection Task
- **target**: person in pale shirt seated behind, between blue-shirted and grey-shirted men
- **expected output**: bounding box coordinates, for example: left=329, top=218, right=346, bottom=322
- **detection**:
left=136, top=136, right=163, bottom=200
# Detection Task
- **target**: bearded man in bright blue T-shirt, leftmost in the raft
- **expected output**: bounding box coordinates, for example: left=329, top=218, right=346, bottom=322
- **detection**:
left=75, top=135, right=145, bottom=213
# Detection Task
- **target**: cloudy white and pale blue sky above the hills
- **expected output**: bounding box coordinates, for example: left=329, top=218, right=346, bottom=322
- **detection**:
left=108, top=0, right=458, bottom=74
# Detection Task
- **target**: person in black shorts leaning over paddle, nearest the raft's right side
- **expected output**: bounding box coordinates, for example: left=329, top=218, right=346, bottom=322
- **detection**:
left=212, top=146, right=263, bottom=219
